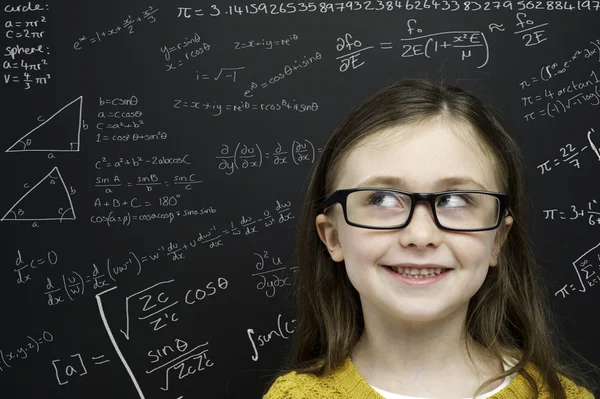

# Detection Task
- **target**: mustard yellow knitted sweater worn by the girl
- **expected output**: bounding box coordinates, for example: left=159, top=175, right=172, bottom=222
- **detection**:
left=263, top=356, right=594, bottom=399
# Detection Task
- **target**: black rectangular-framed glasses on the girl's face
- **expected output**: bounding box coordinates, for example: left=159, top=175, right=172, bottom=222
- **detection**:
left=322, top=187, right=510, bottom=231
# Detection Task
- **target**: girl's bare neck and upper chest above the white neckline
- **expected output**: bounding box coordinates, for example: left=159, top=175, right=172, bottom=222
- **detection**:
left=351, top=309, right=503, bottom=397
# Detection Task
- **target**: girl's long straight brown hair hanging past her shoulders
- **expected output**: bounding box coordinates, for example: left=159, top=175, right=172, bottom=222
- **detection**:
left=268, top=79, right=598, bottom=399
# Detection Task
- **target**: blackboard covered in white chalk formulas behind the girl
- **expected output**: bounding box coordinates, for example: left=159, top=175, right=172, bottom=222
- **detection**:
left=0, top=0, right=600, bottom=399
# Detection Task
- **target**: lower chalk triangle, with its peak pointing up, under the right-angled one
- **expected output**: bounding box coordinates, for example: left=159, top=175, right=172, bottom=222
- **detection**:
left=0, top=167, right=75, bottom=222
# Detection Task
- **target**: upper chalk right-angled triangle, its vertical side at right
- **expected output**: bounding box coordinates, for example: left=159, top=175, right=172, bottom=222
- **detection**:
left=6, top=96, right=83, bottom=152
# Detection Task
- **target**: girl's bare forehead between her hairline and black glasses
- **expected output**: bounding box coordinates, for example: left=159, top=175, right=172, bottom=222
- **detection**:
left=335, top=120, right=500, bottom=192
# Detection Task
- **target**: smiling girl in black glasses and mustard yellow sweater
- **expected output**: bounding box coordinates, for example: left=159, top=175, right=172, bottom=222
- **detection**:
left=264, top=80, right=595, bottom=399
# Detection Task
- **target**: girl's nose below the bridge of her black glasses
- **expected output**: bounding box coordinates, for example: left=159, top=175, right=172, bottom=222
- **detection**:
left=399, top=201, right=442, bottom=248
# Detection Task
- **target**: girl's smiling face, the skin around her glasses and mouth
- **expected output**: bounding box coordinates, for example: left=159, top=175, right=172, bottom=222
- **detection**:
left=316, top=121, right=512, bottom=321
